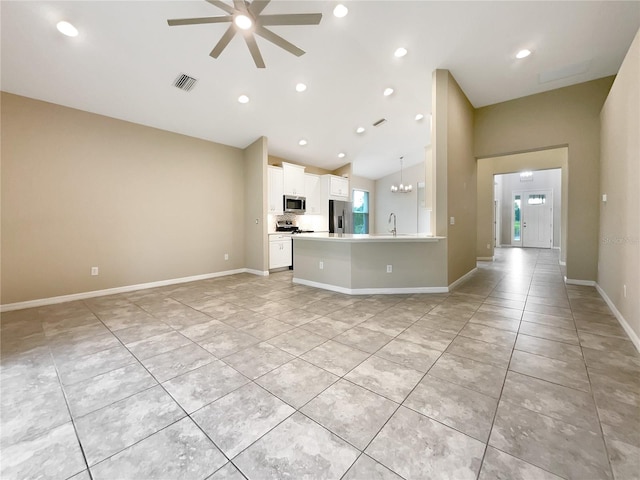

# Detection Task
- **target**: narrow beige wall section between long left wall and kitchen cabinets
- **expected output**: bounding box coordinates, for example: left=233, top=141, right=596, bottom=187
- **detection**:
left=242, top=137, right=269, bottom=274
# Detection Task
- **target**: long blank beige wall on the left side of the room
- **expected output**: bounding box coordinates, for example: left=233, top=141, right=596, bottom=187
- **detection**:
left=1, top=93, right=245, bottom=304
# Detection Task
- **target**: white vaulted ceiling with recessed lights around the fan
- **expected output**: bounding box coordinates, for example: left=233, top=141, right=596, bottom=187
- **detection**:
left=0, top=0, right=640, bottom=179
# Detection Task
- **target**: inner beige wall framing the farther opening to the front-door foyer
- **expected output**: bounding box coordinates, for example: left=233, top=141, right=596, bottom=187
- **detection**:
left=476, top=147, right=568, bottom=262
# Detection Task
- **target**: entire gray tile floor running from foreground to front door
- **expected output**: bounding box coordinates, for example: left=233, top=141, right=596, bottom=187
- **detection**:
left=0, top=249, right=640, bottom=480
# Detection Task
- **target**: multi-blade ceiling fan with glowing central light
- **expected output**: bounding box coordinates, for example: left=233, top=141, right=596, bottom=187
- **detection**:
left=167, top=0, right=322, bottom=68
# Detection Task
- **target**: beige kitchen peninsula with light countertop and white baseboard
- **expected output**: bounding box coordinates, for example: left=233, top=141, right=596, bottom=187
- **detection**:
left=293, top=233, right=448, bottom=295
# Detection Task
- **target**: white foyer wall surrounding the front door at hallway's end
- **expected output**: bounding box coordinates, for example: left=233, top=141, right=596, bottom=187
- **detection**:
left=496, top=168, right=562, bottom=248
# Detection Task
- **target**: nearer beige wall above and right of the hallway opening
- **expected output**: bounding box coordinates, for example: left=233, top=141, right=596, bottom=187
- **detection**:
left=474, top=77, right=613, bottom=280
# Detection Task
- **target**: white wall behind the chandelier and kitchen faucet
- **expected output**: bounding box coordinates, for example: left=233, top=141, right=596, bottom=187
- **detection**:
left=372, top=163, right=430, bottom=233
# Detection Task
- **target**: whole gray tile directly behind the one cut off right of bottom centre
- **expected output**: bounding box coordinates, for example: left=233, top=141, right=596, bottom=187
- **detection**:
left=403, top=375, right=498, bottom=443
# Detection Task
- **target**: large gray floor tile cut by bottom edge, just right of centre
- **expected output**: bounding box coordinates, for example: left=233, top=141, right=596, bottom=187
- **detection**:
left=366, top=407, right=484, bottom=480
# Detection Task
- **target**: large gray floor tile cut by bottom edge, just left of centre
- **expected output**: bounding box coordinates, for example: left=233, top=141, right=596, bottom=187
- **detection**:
left=234, top=413, right=359, bottom=480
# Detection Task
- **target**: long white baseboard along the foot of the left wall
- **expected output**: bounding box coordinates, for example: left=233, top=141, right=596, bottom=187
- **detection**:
left=0, top=268, right=254, bottom=312
